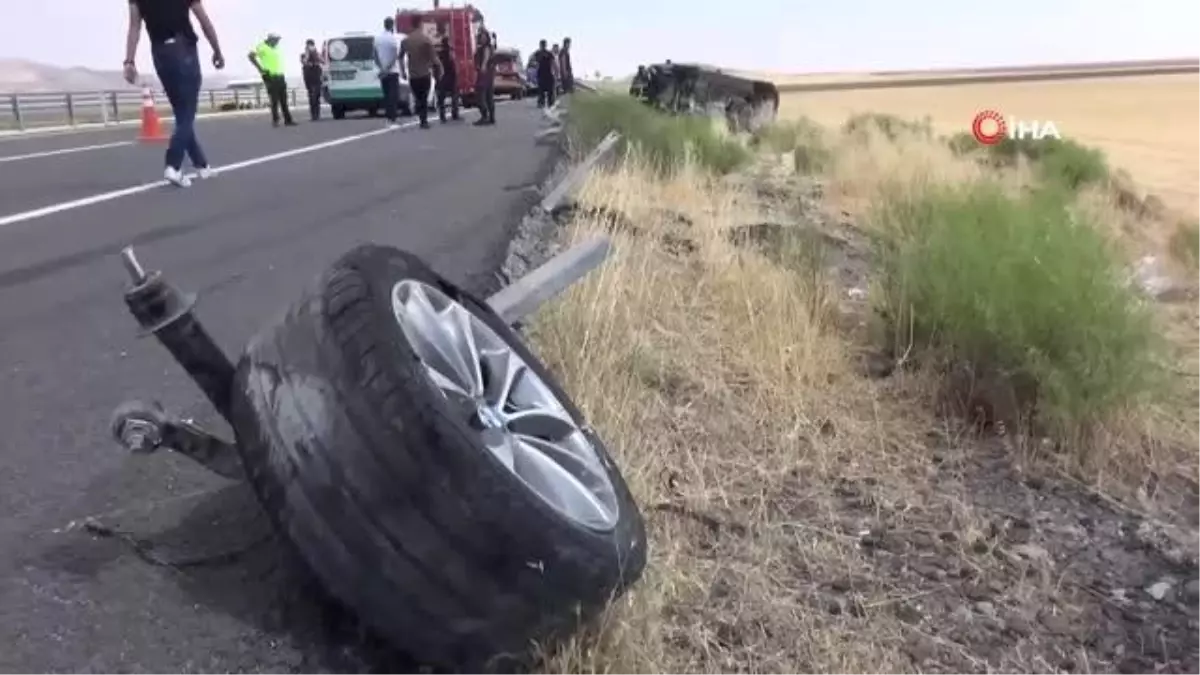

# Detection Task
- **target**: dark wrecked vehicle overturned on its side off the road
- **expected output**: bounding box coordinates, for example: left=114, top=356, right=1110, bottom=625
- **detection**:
left=630, top=61, right=779, bottom=132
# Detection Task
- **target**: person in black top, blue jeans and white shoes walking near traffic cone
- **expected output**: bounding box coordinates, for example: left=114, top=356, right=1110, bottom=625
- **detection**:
left=124, top=0, right=224, bottom=187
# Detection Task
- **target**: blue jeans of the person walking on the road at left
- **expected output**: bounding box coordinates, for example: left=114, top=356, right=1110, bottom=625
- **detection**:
left=150, top=40, right=209, bottom=169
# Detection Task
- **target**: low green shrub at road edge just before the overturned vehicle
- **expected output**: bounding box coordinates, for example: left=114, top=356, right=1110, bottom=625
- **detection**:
left=568, top=92, right=749, bottom=173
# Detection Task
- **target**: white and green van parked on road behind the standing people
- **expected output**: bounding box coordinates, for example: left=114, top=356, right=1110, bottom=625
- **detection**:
left=323, top=31, right=413, bottom=120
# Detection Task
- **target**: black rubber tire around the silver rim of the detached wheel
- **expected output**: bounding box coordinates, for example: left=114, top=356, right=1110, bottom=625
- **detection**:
left=225, top=245, right=647, bottom=669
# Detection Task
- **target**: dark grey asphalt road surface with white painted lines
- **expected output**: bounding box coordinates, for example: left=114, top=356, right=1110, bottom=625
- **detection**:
left=0, top=103, right=561, bottom=675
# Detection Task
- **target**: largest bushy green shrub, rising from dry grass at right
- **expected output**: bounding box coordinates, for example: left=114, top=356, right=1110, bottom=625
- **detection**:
left=872, top=183, right=1160, bottom=432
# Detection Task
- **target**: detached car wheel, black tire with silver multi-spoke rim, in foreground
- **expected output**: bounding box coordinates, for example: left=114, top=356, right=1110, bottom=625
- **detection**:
left=233, top=245, right=646, bottom=668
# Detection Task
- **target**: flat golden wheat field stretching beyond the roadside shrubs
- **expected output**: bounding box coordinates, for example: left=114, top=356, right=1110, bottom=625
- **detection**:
left=780, top=74, right=1200, bottom=214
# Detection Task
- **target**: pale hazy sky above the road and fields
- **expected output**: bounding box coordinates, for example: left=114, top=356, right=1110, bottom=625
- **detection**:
left=7, top=0, right=1200, bottom=77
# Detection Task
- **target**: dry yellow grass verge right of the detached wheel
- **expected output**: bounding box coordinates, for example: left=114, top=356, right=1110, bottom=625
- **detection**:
left=532, top=86, right=1200, bottom=675
